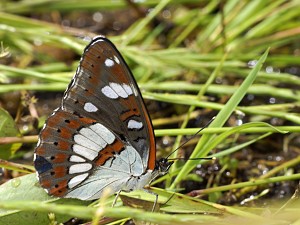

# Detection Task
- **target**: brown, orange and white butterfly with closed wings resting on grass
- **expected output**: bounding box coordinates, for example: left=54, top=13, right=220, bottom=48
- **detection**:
left=34, top=37, right=172, bottom=200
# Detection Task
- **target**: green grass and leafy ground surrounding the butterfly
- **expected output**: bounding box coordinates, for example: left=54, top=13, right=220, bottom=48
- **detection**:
left=0, top=0, right=300, bottom=225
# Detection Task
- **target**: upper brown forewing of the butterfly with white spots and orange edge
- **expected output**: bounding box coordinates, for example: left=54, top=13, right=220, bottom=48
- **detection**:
left=62, top=37, right=155, bottom=169
